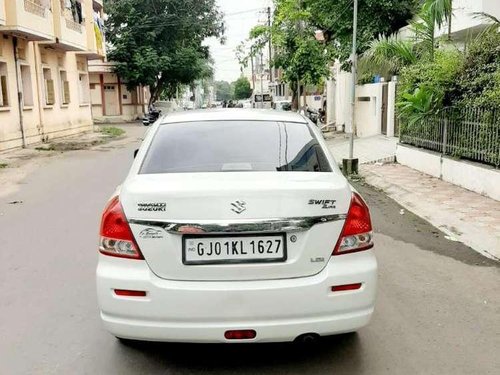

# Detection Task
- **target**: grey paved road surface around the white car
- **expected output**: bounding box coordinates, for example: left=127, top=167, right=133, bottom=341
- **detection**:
left=0, top=126, right=500, bottom=374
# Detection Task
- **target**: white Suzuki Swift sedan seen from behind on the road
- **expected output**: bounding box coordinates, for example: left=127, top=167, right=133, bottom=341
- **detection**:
left=97, top=109, right=377, bottom=343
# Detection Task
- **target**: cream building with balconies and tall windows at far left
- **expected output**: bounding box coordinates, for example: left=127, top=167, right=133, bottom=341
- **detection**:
left=0, top=0, right=105, bottom=151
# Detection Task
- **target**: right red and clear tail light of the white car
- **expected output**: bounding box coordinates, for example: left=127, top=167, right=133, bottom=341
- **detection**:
left=333, top=193, right=373, bottom=255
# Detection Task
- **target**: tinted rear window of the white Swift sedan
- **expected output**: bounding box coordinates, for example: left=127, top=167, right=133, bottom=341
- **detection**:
left=140, top=121, right=331, bottom=174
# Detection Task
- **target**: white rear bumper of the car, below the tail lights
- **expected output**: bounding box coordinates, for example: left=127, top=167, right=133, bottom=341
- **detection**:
left=97, top=251, right=377, bottom=343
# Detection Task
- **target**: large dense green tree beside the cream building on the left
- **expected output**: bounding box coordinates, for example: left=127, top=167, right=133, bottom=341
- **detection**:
left=105, top=0, right=223, bottom=106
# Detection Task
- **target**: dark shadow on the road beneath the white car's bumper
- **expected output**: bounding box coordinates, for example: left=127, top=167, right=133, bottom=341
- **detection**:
left=116, top=334, right=362, bottom=374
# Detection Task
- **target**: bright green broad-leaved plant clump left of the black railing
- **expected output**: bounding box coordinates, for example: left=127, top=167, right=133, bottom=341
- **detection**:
left=397, top=86, right=442, bottom=126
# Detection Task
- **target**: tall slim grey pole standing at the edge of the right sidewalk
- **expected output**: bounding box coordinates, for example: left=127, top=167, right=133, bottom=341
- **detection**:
left=342, top=0, right=358, bottom=175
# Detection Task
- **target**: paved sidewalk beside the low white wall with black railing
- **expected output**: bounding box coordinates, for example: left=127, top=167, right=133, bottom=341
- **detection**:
left=360, top=164, right=500, bottom=261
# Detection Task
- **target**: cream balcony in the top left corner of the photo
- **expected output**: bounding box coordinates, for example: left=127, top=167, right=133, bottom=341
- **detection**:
left=0, top=0, right=54, bottom=41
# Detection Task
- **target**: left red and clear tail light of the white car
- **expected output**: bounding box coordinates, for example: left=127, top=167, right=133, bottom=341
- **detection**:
left=99, top=197, right=144, bottom=259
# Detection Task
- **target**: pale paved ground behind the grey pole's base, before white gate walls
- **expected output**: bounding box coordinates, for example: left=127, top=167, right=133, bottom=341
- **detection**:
left=326, top=133, right=398, bottom=164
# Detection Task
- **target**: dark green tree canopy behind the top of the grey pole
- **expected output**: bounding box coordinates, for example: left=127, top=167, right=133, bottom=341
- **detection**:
left=304, top=0, right=420, bottom=67
